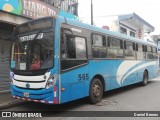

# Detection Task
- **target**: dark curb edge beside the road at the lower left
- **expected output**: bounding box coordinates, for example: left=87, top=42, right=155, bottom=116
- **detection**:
left=0, top=99, right=25, bottom=110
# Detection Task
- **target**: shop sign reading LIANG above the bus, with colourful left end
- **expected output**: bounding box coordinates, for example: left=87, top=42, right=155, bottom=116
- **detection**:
left=0, top=0, right=59, bottom=19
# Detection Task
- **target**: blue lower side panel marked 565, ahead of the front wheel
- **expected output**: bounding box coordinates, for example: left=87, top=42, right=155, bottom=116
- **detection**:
left=61, top=65, right=89, bottom=103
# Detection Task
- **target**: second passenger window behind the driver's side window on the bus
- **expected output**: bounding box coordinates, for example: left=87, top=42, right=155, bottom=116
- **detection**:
left=108, top=37, right=123, bottom=58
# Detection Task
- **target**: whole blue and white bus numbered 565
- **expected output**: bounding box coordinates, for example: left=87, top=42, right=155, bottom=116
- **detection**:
left=10, top=16, right=158, bottom=104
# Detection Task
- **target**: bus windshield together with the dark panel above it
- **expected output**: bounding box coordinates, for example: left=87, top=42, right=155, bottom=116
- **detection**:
left=10, top=18, right=55, bottom=75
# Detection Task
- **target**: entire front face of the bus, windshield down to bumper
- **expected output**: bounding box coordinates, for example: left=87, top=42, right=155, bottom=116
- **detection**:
left=10, top=17, right=58, bottom=104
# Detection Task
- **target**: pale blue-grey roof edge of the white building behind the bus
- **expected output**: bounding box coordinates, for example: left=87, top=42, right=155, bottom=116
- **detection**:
left=118, top=13, right=155, bottom=32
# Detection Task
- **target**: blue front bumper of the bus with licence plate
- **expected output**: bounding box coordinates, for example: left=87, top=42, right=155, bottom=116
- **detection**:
left=10, top=84, right=58, bottom=104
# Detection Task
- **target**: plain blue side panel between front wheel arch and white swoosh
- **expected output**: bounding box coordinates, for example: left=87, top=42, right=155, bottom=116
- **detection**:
left=89, top=60, right=123, bottom=91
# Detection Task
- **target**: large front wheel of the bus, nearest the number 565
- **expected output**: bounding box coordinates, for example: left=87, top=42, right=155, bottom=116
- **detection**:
left=89, top=78, right=103, bottom=104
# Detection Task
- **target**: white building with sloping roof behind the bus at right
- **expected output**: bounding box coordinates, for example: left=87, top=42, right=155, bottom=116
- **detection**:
left=102, top=13, right=155, bottom=39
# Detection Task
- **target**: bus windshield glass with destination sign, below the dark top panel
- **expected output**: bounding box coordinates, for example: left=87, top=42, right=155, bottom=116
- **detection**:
left=11, top=30, right=54, bottom=71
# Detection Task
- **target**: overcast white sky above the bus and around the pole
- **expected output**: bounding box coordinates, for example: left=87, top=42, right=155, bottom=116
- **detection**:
left=79, top=0, right=160, bottom=35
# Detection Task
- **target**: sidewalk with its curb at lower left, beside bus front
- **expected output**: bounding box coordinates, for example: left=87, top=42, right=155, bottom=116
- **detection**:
left=0, top=92, right=25, bottom=110
